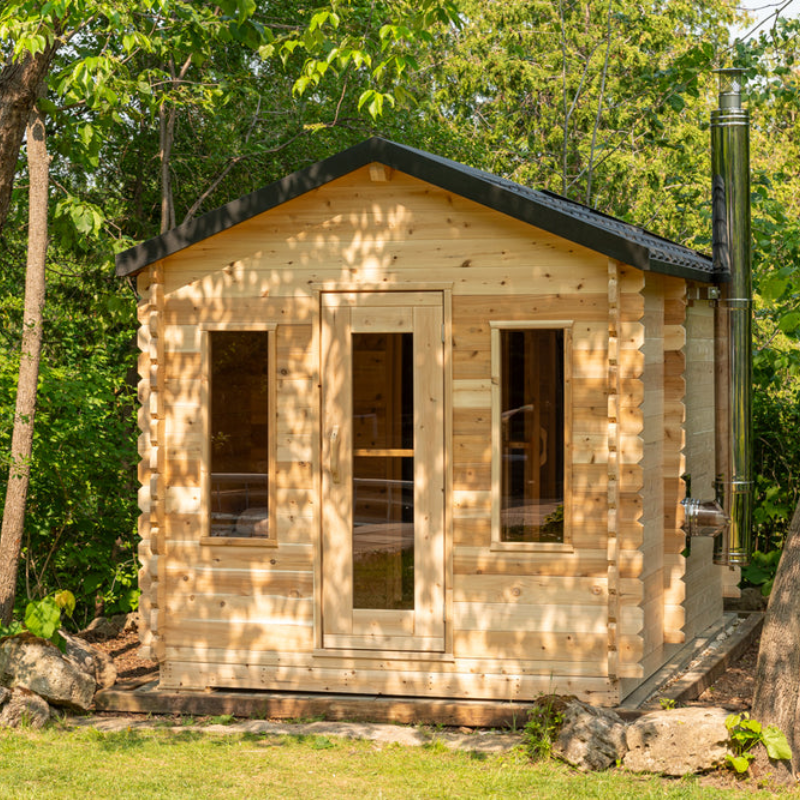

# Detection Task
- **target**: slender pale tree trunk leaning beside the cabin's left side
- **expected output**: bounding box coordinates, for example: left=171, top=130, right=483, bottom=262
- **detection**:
left=0, top=101, right=50, bottom=625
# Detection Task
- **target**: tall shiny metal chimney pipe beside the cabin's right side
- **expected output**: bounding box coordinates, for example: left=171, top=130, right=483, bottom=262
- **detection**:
left=711, top=69, right=753, bottom=566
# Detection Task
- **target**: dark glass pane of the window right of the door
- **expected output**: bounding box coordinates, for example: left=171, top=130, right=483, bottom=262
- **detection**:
left=500, top=329, right=564, bottom=542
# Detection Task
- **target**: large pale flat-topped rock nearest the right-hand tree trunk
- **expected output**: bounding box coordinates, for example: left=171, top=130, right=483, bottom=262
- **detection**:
left=623, top=708, right=728, bottom=776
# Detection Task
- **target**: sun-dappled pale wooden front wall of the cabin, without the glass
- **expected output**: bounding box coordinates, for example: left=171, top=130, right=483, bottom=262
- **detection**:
left=136, top=162, right=680, bottom=702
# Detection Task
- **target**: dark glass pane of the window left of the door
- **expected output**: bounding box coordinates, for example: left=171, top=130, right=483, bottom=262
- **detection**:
left=210, top=331, right=270, bottom=538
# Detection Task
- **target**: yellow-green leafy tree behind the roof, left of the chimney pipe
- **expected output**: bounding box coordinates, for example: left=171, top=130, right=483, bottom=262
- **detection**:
left=406, top=0, right=733, bottom=241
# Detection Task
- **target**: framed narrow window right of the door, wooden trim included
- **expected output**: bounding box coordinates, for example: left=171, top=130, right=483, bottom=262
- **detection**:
left=492, top=322, right=571, bottom=549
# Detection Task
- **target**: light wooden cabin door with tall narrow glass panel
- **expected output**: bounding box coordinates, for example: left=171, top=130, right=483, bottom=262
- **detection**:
left=321, top=292, right=444, bottom=652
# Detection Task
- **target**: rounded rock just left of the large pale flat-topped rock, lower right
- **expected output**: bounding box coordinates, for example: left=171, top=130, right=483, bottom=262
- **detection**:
left=552, top=700, right=627, bottom=772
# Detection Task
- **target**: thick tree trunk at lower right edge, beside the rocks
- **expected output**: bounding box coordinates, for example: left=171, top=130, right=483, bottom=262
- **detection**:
left=753, top=503, right=800, bottom=774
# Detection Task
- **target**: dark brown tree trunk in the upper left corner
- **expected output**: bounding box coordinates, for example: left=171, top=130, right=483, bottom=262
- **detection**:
left=0, top=45, right=58, bottom=238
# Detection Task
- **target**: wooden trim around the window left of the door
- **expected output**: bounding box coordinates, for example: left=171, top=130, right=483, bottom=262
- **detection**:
left=199, top=322, right=278, bottom=547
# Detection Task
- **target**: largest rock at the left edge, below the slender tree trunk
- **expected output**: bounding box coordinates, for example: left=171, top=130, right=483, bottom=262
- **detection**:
left=0, top=633, right=97, bottom=711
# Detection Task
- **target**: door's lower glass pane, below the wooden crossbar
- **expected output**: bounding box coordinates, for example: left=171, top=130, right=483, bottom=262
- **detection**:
left=353, top=457, right=414, bottom=609
